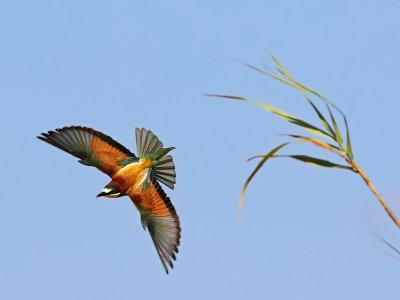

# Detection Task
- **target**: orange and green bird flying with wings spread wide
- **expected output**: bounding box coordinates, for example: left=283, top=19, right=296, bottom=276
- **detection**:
left=38, top=126, right=181, bottom=274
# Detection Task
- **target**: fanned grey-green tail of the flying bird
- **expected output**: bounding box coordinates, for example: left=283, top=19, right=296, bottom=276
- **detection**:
left=135, top=128, right=176, bottom=189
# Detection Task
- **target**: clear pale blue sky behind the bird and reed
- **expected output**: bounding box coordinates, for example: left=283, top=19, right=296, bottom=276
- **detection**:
left=0, top=1, right=400, bottom=300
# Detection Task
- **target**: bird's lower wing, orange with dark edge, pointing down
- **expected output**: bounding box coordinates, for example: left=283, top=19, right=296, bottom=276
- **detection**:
left=131, top=176, right=181, bottom=274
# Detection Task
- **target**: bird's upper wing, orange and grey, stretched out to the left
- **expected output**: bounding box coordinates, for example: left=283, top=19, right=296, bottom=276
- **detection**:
left=38, top=126, right=136, bottom=177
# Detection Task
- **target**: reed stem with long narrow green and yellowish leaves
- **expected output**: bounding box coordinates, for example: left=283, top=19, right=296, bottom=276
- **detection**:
left=208, top=54, right=400, bottom=227
